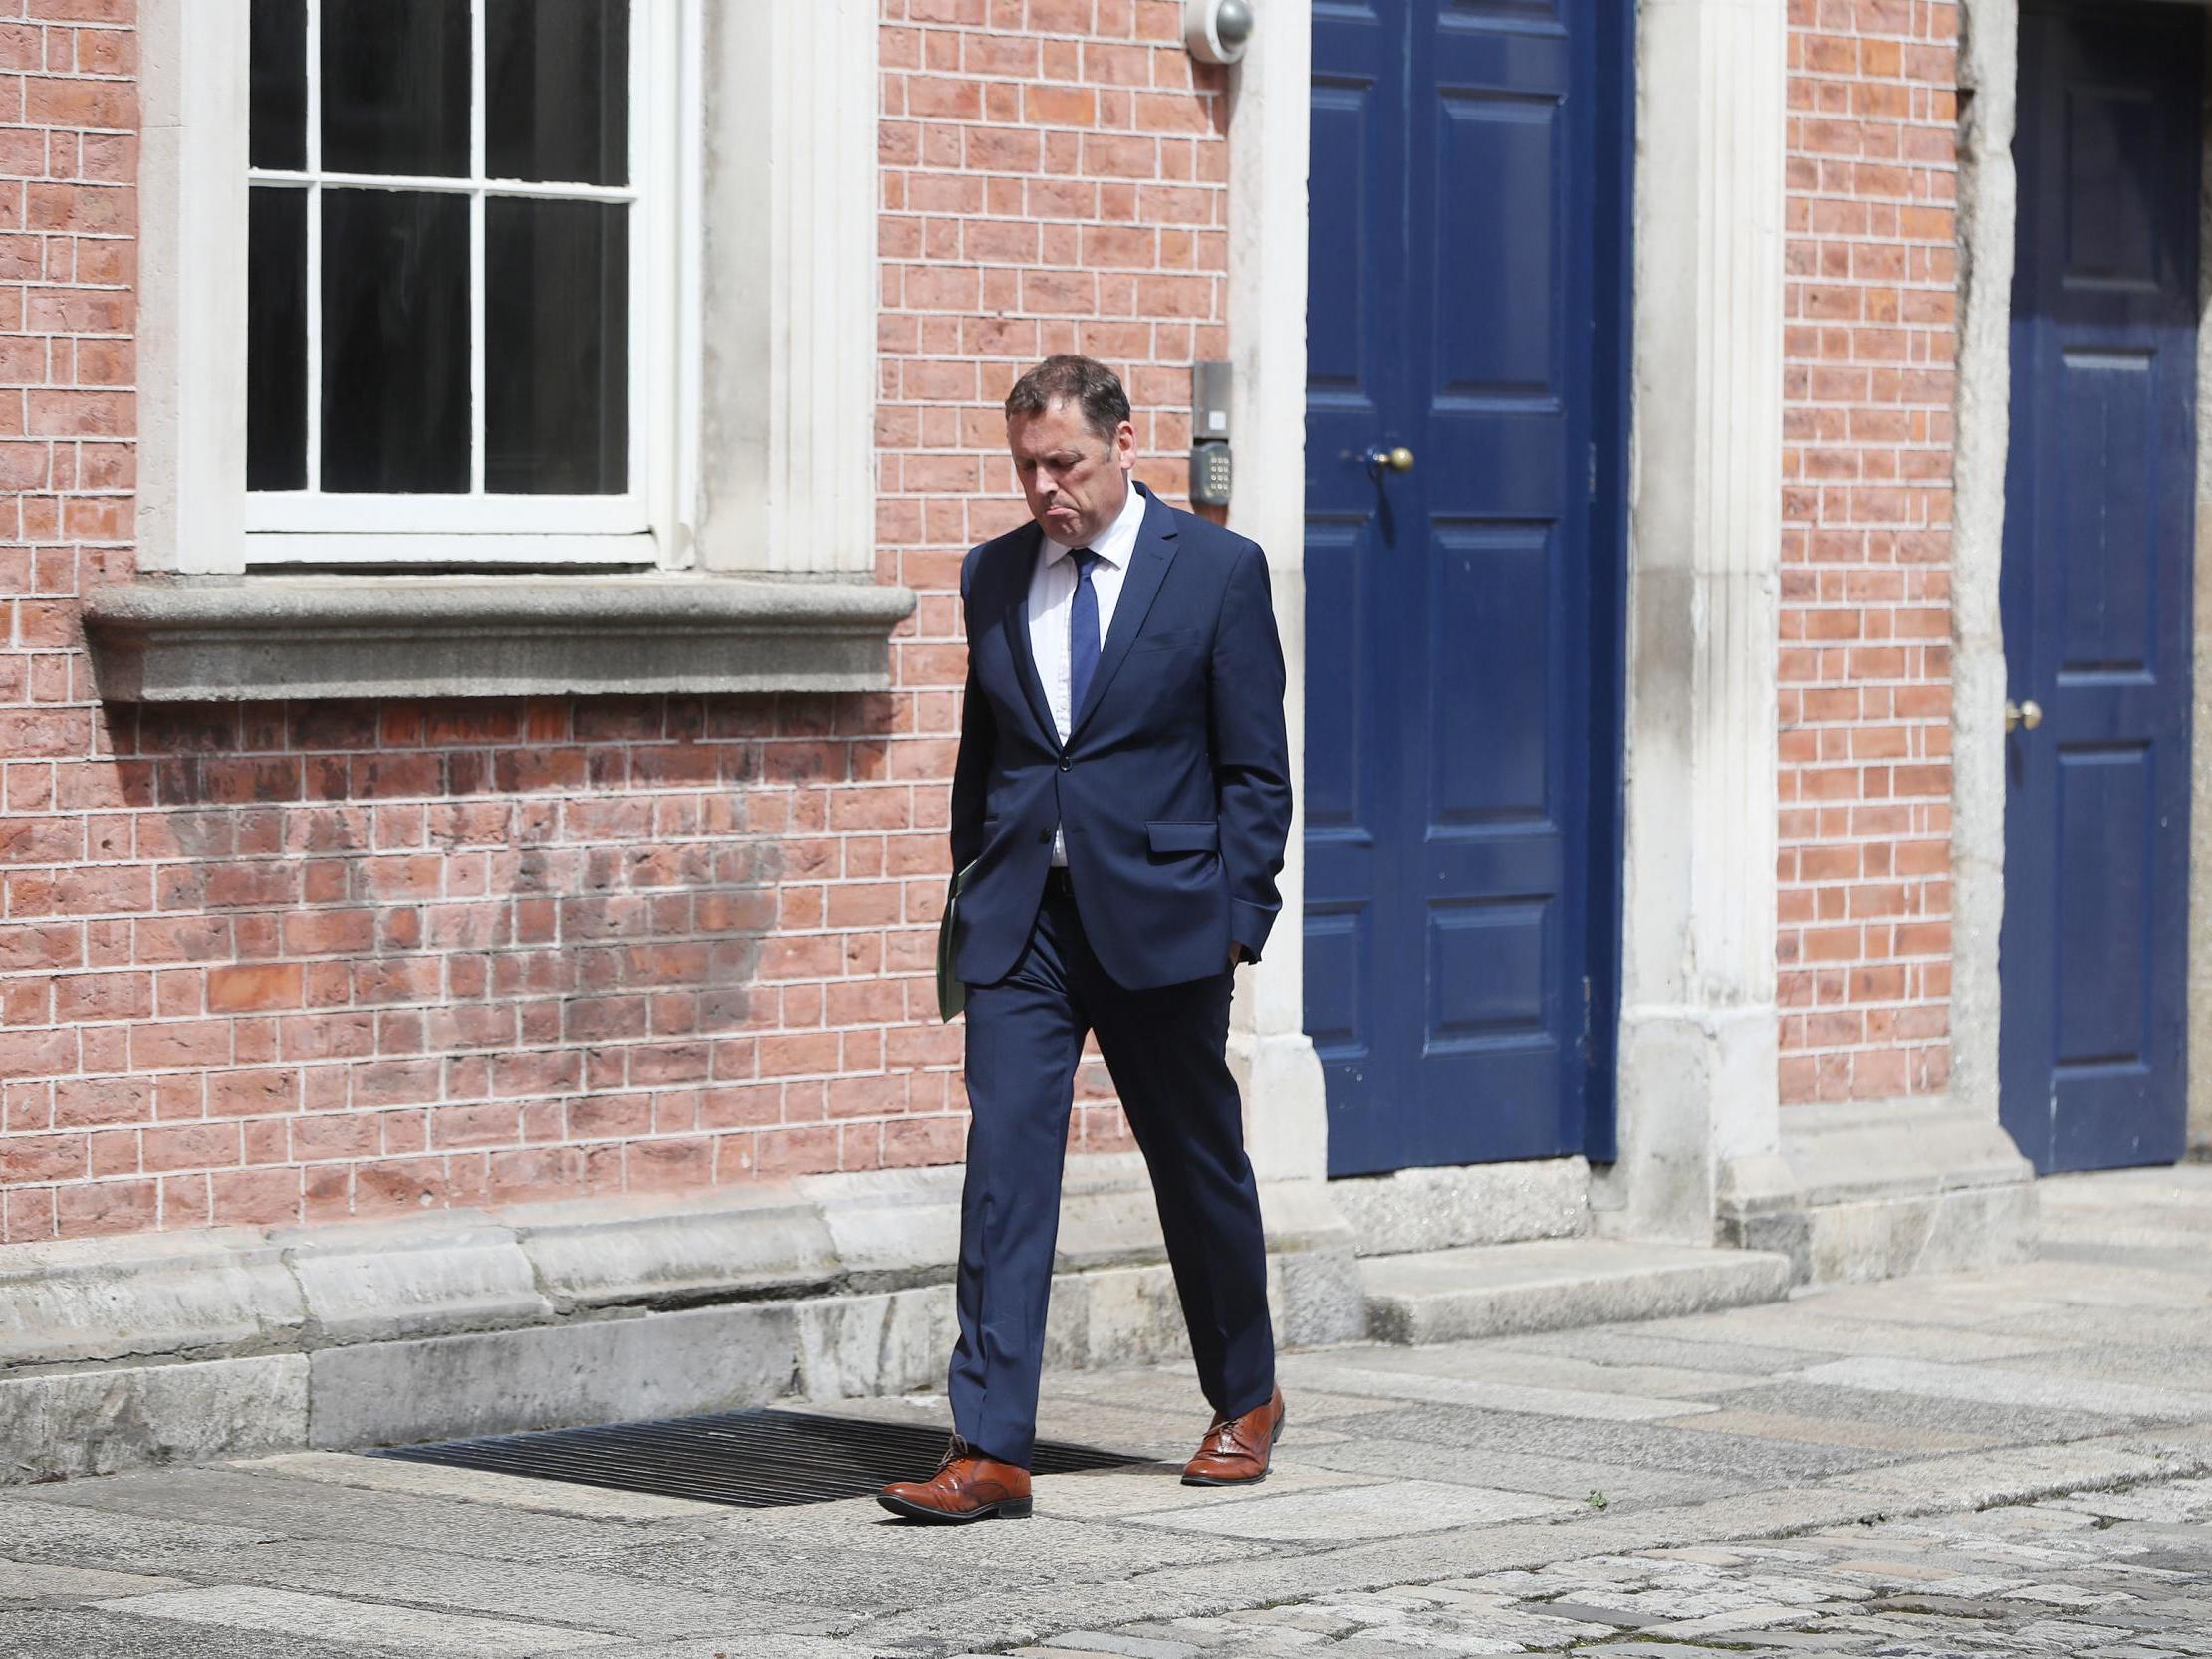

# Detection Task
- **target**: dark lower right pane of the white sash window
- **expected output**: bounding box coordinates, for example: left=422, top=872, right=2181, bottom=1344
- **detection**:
left=484, top=197, right=630, bottom=496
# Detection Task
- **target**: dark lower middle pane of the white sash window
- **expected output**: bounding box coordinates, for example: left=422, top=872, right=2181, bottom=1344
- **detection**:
left=323, top=190, right=469, bottom=493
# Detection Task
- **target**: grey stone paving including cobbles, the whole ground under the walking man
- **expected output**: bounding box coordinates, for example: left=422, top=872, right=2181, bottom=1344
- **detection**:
left=0, top=1166, right=2212, bottom=1659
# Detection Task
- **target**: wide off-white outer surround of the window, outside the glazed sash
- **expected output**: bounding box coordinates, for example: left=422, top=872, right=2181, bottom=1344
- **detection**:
left=137, top=0, right=880, bottom=582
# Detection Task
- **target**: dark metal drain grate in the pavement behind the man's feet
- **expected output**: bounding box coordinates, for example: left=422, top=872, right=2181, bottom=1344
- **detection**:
left=368, top=1411, right=1150, bottom=1509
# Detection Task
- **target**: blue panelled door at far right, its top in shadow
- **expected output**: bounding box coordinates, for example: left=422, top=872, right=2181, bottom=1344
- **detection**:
left=2000, top=4, right=2203, bottom=1170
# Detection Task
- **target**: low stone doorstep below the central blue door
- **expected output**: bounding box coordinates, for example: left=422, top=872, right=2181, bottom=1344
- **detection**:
left=1360, top=1239, right=1790, bottom=1347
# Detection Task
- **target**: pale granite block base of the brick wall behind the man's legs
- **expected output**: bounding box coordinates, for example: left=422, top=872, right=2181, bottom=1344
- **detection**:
left=0, top=1157, right=1364, bottom=1482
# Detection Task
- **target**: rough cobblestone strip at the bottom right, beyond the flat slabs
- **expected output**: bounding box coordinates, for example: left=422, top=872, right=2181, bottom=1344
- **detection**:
left=1015, top=1480, right=2212, bottom=1659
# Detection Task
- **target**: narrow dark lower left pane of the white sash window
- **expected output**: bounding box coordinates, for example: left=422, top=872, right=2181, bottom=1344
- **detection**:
left=246, top=186, right=308, bottom=489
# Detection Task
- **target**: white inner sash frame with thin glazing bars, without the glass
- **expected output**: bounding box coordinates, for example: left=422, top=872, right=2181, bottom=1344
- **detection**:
left=246, top=0, right=676, bottom=569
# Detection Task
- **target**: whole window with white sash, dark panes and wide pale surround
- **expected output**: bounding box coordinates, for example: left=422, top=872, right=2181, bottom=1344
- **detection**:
left=132, top=0, right=880, bottom=596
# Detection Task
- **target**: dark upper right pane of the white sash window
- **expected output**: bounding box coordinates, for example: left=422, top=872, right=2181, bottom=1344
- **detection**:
left=484, top=0, right=630, bottom=183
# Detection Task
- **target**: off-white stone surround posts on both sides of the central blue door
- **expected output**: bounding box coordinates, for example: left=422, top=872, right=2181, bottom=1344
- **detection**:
left=1230, top=0, right=1788, bottom=1241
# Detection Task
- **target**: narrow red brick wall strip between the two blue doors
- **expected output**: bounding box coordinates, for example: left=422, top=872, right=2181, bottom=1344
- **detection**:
left=1779, top=0, right=1958, bottom=1118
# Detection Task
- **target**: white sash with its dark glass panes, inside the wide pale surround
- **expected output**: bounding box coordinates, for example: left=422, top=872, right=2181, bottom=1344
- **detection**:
left=246, top=0, right=681, bottom=569
